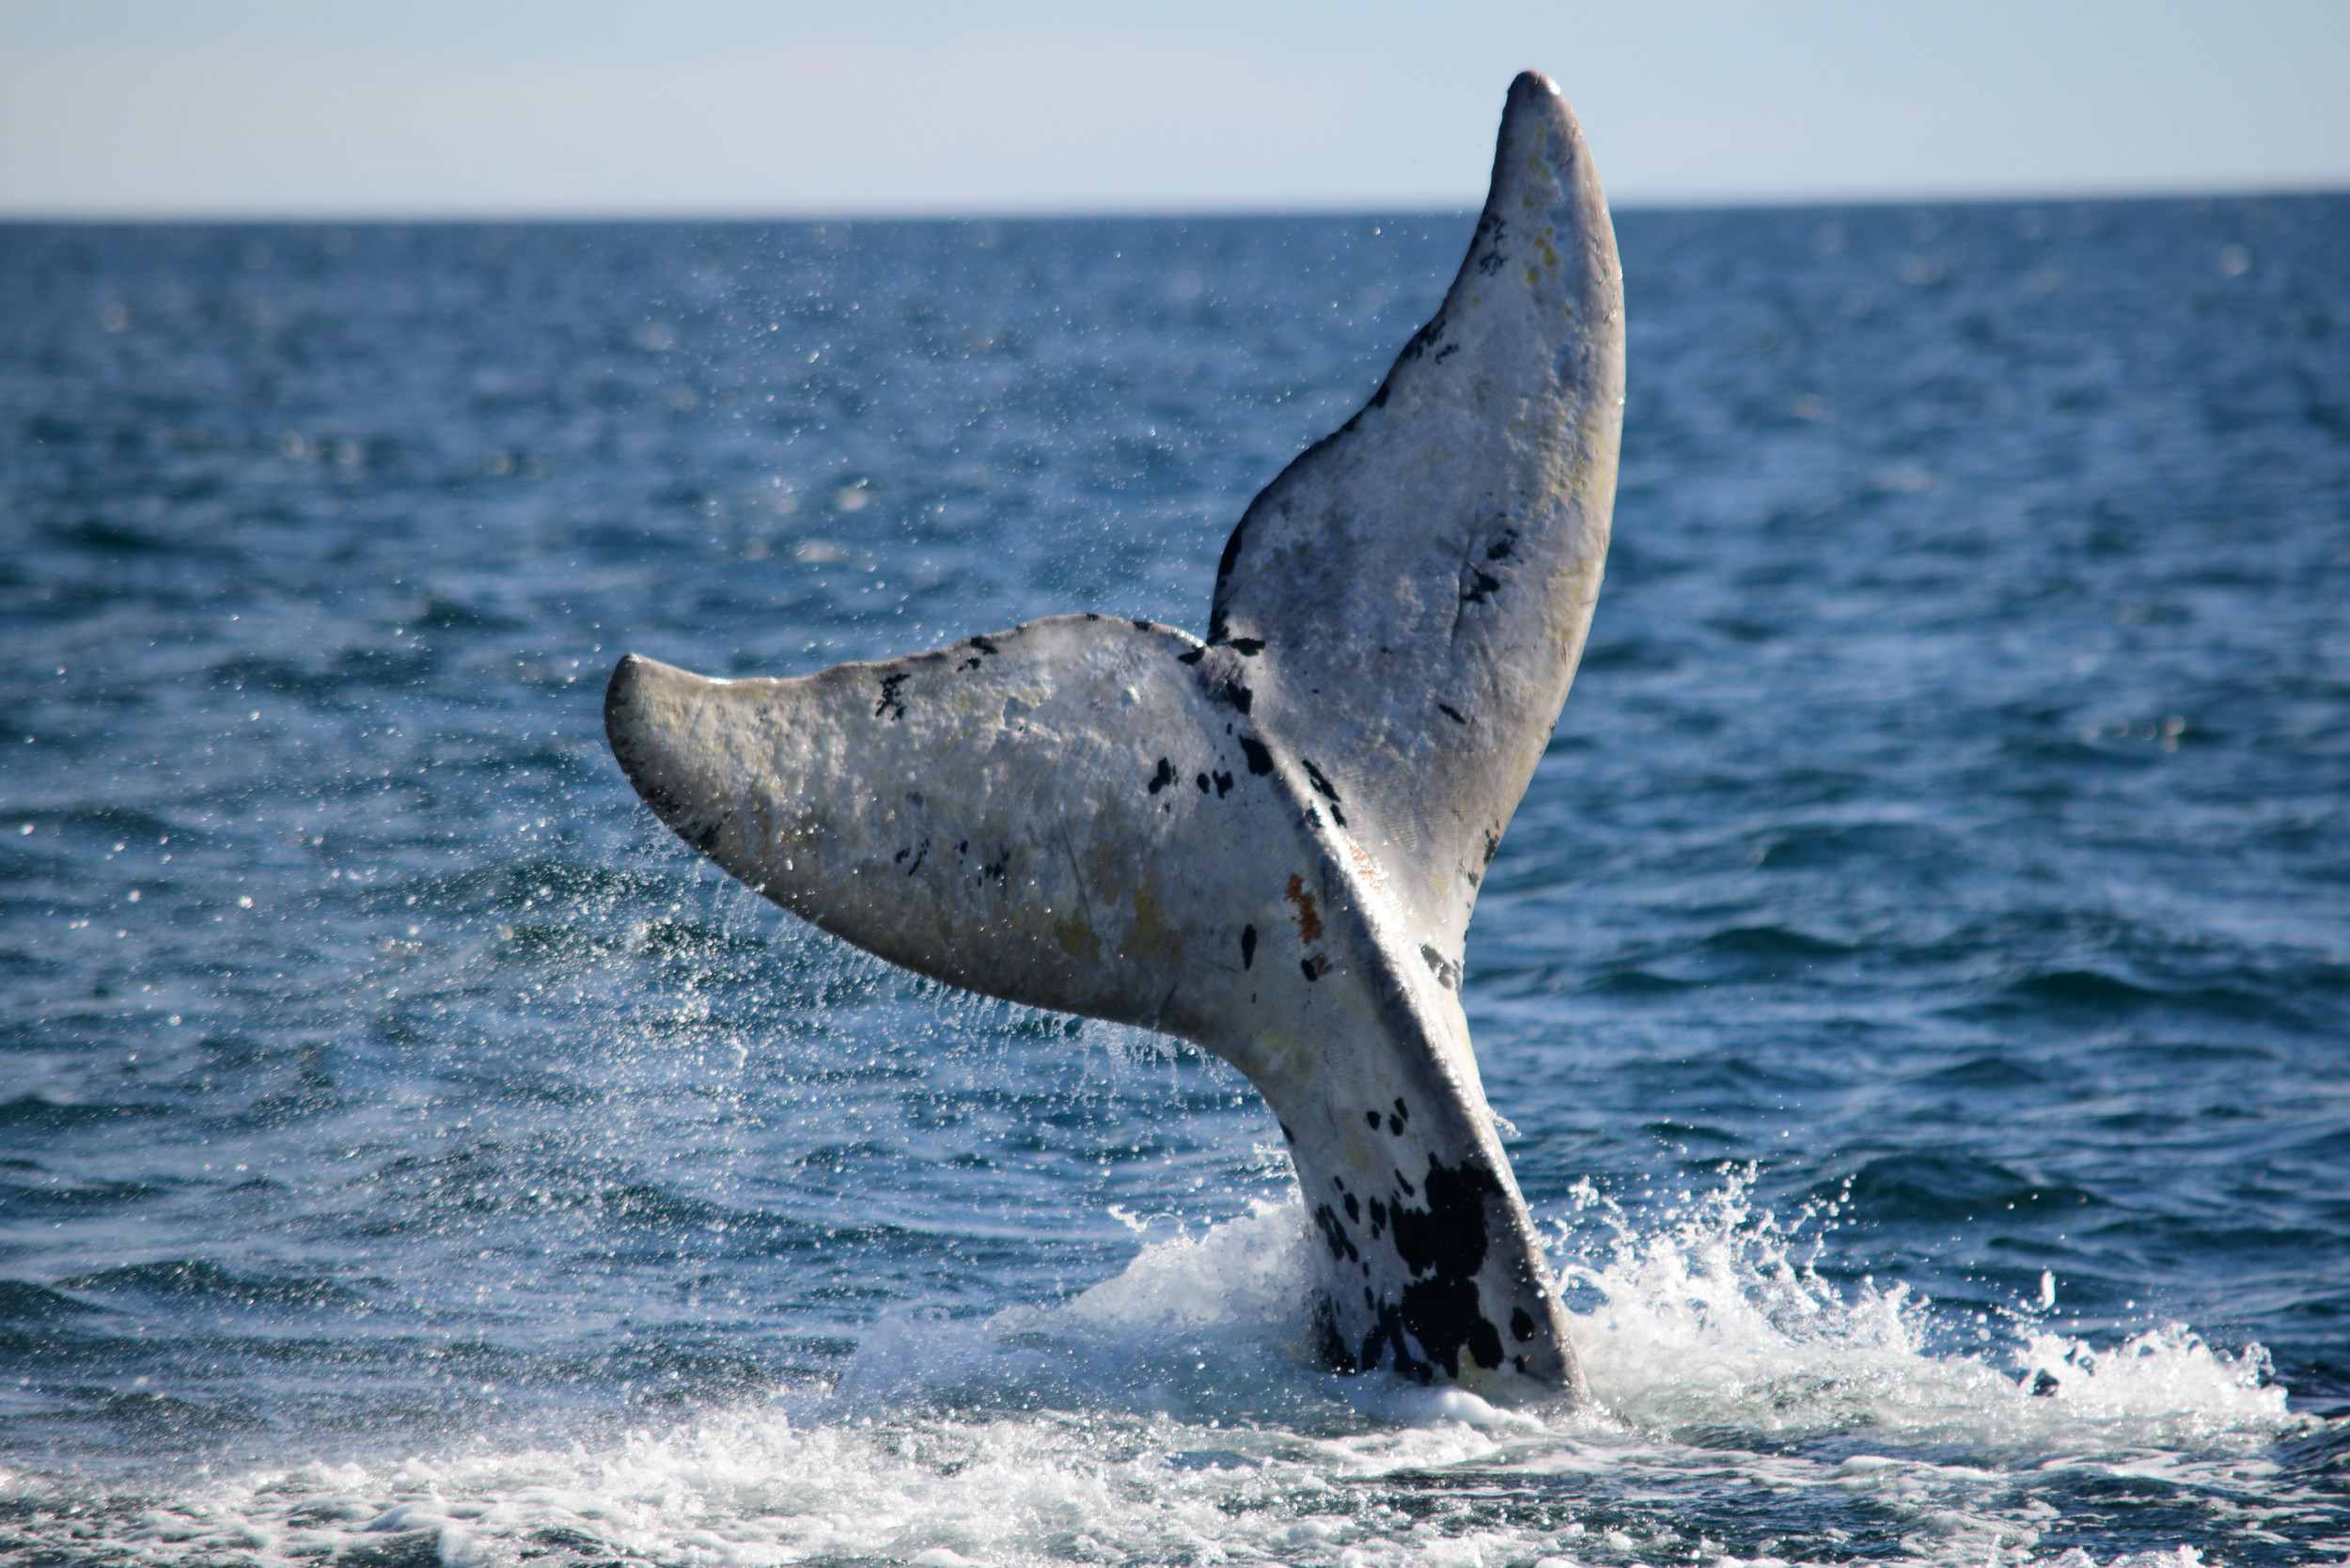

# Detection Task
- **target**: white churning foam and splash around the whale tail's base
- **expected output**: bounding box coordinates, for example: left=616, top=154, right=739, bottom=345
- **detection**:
left=0, top=1180, right=2292, bottom=1568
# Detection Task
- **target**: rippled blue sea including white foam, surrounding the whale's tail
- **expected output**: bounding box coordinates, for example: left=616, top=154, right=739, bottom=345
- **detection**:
left=0, top=197, right=2350, bottom=1568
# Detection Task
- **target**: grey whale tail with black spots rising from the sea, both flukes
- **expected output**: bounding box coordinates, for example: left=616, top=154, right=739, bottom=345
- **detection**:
left=604, top=73, right=1624, bottom=1396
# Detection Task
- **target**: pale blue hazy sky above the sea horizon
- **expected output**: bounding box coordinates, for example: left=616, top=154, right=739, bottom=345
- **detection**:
left=0, top=0, right=2350, bottom=219
